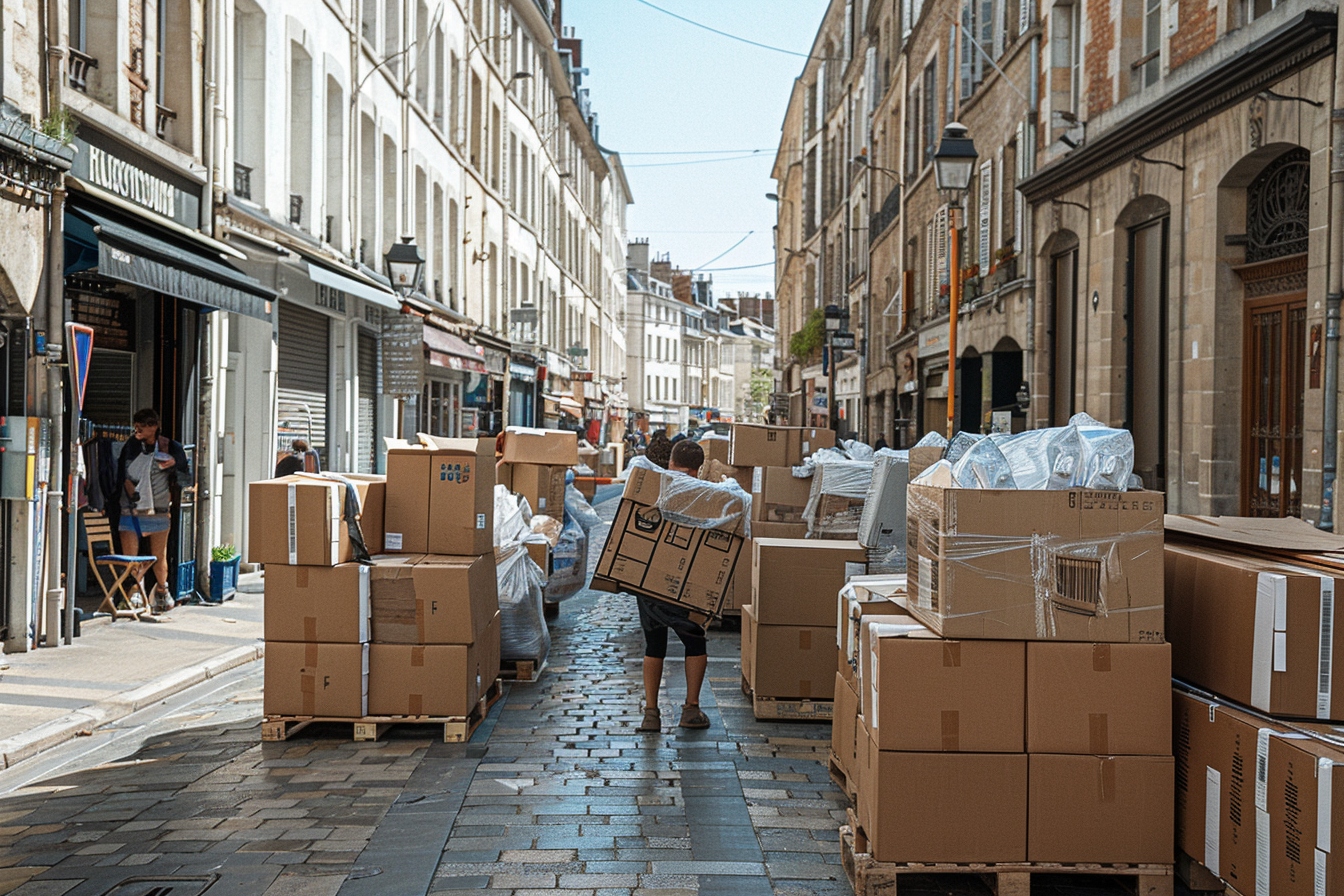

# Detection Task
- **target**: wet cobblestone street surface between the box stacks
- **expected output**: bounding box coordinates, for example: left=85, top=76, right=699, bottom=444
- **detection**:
left=0, top=501, right=851, bottom=896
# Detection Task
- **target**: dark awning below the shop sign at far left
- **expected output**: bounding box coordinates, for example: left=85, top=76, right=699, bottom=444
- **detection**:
left=66, top=207, right=277, bottom=321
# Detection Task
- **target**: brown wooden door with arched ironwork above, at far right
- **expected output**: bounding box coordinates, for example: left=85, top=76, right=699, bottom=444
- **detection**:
left=1235, top=148, right=1310, bottom=517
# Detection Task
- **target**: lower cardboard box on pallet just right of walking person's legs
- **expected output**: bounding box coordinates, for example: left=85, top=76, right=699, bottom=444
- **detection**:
left=750, top=617, right=836, bottom=700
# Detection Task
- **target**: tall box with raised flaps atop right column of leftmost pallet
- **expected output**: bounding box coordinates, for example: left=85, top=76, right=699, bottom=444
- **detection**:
left=383, top=437, right=495, bottom=555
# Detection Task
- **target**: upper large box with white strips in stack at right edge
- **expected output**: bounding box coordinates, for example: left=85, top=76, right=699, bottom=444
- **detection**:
left=1167, top=545, right=1344, bottom=720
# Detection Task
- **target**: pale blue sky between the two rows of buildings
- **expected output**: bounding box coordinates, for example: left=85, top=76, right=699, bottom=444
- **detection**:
left=563, top=0, right=827, bottom=296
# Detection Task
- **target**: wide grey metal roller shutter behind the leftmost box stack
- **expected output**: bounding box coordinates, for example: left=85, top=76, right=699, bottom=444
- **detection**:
left=276, top=302, right=331, bottom=469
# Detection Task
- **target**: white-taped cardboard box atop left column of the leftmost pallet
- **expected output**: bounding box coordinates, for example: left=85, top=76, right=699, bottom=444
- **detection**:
left=247, top=476, right=355, bottom=567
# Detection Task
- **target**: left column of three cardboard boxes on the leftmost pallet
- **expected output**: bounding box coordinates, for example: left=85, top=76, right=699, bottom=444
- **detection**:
left=247, top=476, right=384, bottom=719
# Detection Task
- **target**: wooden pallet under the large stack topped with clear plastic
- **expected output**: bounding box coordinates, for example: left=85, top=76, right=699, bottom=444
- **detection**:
left=840, top=810, right=1176, bottom=896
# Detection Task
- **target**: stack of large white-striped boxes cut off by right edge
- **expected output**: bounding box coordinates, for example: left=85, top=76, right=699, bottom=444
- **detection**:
left=1167, top=517, right=1344, bottom=896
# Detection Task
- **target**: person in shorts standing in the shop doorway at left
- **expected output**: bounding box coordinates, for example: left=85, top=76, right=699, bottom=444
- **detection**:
left=117, top=407, right=190, bottom=613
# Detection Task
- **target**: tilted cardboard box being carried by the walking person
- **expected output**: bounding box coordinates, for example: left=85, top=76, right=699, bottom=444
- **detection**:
left=590, top=469, right=747, bottom=615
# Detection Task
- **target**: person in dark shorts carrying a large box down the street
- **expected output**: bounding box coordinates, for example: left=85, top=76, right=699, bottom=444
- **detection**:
left=636, top=439, right=710, bottom=732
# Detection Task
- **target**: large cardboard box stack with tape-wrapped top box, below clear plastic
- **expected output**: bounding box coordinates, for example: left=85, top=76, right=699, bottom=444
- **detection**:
left=835, top=485, right=1175, bottom=864
